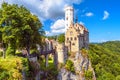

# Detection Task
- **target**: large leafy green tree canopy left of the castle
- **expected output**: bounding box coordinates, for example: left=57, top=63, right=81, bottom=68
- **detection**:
left=0, top=3, right=44, bottom=54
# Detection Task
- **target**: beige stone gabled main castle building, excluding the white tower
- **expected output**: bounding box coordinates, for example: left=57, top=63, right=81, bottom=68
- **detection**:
left=65, top=23, right=89, bottom=52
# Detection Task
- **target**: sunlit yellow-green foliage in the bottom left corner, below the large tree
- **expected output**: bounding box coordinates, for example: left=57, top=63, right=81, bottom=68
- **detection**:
left=0, top=56, right=28, bottom=80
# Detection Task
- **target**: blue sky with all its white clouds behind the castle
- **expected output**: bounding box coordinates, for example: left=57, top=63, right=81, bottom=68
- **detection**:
left=0, top=0, right=120, bottom=42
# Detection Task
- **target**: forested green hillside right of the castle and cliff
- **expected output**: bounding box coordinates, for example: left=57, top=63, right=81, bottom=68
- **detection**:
left=89, top=41, right=120, bottom=80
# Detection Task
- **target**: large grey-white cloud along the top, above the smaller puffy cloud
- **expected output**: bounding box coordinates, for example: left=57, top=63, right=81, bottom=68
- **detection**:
left=5, top=0, right=82, bottom=20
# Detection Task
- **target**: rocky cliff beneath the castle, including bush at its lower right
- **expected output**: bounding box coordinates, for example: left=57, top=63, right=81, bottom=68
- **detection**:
left=58, top=51, right=96, bottom=80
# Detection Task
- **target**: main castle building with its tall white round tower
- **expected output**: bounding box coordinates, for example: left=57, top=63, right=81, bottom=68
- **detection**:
left=65, top=6, right=89, bottom=52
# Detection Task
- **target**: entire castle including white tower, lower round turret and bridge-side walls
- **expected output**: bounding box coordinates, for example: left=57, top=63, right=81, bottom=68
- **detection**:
left=37, top=6, right=89, bottom=64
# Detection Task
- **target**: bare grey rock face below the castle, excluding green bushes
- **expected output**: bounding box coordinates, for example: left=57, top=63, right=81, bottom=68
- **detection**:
left=58, top=52, right=96, bottom=80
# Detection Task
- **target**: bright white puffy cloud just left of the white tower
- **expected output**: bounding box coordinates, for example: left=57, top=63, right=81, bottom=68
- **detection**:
left=46, top=19, right=65, bottom=36
